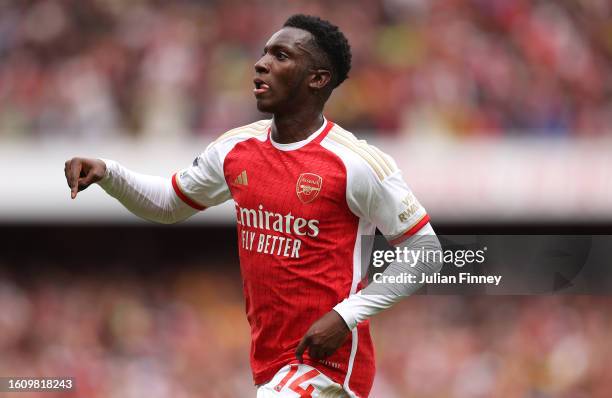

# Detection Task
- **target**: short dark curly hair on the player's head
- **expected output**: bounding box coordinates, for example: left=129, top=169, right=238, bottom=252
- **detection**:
left=283, top=14, right=351, bottom=88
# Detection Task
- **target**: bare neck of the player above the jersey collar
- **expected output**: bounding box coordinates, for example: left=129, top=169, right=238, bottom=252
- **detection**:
left=272, top=109, right=324, bottom=144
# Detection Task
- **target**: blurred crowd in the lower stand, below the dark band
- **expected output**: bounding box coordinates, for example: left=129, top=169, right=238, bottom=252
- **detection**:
left=0, top=267, right=612, bottom=398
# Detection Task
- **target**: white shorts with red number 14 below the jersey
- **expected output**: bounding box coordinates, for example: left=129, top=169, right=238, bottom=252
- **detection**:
left=257, top=363, right=349, bottom=398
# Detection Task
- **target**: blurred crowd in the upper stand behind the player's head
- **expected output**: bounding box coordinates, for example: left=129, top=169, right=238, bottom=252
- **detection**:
left=0, top=0, right=612, bottom=140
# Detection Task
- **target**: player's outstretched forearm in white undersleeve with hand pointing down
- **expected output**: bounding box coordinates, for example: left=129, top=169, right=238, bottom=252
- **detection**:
left=64, top=158, right=197, bottom=224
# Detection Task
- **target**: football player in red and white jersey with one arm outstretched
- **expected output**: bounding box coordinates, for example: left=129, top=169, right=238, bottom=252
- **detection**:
left=65, top=15, right=439, bottom=397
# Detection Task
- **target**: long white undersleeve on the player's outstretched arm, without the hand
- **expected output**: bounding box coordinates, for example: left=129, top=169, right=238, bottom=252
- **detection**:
left=98, top=159, right=197, bottom=224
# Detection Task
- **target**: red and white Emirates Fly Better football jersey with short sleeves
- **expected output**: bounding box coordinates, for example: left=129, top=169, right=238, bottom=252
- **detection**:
left=172, top=120, right=429, bottom=397
